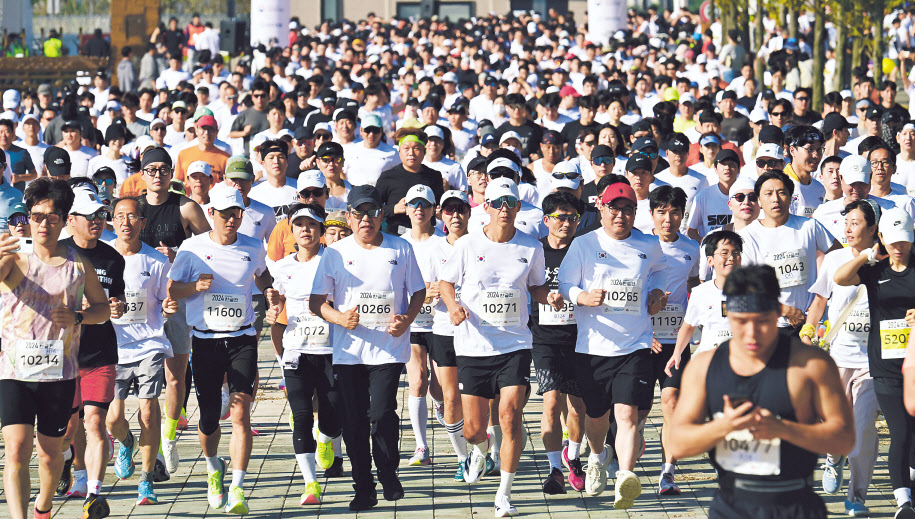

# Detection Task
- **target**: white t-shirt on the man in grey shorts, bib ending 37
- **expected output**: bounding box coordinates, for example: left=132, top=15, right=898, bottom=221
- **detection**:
left=111, top=243, right=174, bottom=364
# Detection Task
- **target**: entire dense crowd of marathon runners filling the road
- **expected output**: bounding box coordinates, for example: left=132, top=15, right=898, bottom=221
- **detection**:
left=8, top=9, right=915, bottom=519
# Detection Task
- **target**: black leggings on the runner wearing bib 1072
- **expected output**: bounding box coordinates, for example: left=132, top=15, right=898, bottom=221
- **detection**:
left=283, top=353, right=342, bottom=457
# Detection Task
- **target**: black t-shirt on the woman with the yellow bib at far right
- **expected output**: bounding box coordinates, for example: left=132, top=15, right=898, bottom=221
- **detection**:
left=858, top=256, right=915, bottom=388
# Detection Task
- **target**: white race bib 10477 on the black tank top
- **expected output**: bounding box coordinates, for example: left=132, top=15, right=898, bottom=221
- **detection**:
left=715, top=412, right=782, bottom=476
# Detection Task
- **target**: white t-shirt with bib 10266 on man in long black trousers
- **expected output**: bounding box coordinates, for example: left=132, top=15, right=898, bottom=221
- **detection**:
left=312, top=234, right=426, bottom=365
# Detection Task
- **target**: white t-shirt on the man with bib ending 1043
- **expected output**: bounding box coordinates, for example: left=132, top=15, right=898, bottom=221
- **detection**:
left=738, top=215, right=835, bottom=326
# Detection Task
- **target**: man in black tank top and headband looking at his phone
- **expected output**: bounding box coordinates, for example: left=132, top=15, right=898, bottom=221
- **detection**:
left=666, top=265, right=855, bottom=518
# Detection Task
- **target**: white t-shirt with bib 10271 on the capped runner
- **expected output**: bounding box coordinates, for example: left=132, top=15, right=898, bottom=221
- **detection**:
left=441, top=229, right=546, bottom=357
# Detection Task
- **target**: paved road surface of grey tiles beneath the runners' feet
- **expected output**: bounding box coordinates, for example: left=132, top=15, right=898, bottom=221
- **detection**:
left=0, top=338, right=908, bottom=519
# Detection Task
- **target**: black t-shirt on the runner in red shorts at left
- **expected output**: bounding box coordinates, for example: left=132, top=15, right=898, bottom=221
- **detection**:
left=61, top=238, right=124, bottom=368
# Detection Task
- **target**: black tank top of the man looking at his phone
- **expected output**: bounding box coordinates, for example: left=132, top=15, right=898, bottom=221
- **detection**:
left=705, top=335, right=818, bottom=481
